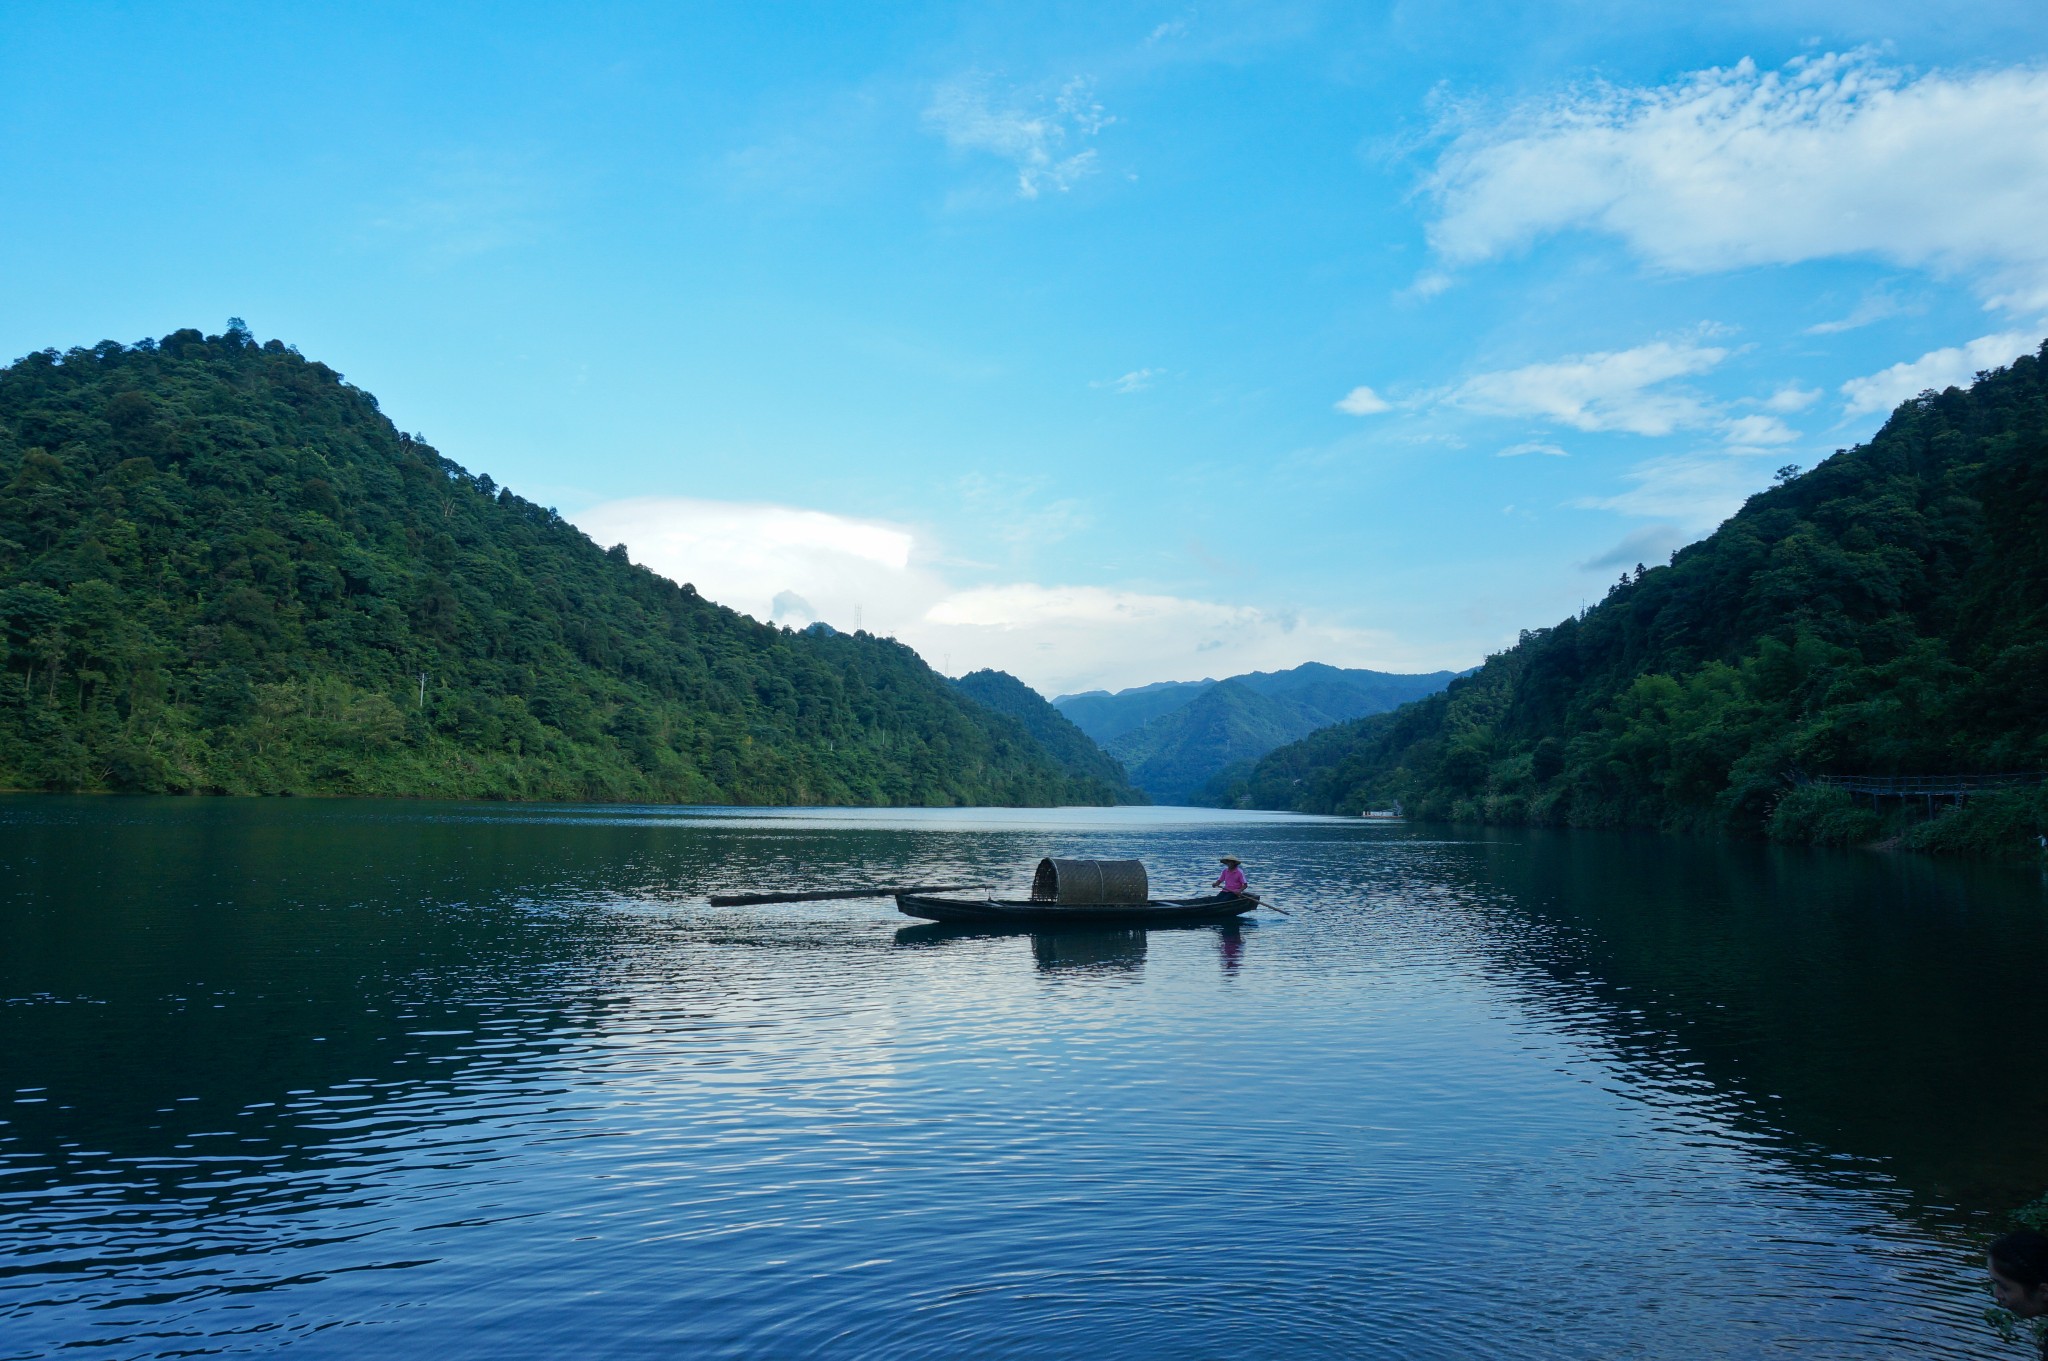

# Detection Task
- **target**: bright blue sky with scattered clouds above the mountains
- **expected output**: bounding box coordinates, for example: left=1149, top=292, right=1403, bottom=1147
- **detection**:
left=0, top=0, right=2048, bottom=694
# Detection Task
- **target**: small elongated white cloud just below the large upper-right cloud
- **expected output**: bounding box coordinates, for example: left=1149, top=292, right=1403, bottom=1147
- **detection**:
left=1448, top=340, right=1729, bottom=436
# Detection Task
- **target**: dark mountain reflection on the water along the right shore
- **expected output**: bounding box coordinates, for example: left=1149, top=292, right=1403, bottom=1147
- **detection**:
left=1470, top=831, right=2048, bottom=1222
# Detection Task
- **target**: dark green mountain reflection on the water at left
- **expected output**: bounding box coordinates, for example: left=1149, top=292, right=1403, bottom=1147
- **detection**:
left=0, top=800, right=638, bottom=1203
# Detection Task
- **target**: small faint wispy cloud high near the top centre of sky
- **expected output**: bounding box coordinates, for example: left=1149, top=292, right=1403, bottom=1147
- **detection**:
left=924, top=74, right=1116, bottom=199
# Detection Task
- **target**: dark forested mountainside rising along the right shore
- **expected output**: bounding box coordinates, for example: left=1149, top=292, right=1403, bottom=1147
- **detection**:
left=1231, top=339, right=2048, bottom=849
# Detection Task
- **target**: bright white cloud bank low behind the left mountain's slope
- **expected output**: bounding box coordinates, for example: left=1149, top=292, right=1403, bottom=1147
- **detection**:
left=573, top=497, right=1440, bottom=694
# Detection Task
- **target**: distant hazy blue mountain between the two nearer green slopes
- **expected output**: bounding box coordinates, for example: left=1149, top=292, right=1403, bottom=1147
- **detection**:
left=1057, top=661, right=1452, bottom=802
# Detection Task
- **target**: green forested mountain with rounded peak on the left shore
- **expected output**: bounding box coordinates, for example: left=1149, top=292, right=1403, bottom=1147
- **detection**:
left=0, top=323, right=1104, bottom=804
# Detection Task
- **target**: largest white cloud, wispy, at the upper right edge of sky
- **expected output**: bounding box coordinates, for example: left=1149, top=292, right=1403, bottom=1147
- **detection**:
left=1427, top=53, right=2048, bottom=307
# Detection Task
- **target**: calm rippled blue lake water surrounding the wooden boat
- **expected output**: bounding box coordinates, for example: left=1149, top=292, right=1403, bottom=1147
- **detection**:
left=0, top=798, right=2048, bottom=1361
